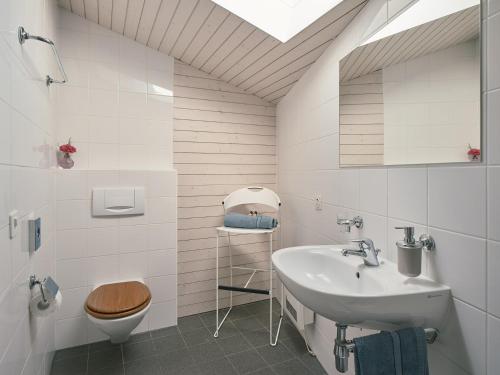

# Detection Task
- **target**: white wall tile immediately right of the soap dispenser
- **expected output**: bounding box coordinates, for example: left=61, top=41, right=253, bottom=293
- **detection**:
left=427, top=228, right=486, bottom=310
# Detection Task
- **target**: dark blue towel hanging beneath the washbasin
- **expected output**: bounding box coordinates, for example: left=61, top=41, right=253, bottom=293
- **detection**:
left=354, top=328, right=429, bottom=375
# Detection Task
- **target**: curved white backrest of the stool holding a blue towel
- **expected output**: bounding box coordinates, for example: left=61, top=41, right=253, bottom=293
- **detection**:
left=222, top=186, right=281, bottom=211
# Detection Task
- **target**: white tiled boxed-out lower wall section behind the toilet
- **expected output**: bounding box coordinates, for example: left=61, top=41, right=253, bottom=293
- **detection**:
left=55, top=170, right=177, bottom=349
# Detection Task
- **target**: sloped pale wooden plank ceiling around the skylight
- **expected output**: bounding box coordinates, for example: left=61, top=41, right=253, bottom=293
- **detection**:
left=58, top=0, right=367, bottom=103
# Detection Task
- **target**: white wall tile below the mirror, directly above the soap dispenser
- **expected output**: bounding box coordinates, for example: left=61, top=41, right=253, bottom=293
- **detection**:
left=387, top=168, right=427, bottom=224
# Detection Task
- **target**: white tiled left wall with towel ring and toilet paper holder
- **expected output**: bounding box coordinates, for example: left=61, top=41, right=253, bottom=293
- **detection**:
left=0, top=0, right=56, bottom=375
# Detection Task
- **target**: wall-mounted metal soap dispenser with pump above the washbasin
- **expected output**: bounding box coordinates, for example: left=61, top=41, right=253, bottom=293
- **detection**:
left=395, top=227, right=434, bottom=277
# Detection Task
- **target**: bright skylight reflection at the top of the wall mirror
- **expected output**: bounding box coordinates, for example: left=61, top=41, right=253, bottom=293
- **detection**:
left=363, top=0, right=480, bottom=45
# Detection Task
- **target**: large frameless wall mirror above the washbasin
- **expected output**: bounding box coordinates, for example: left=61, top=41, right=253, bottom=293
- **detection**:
left=339, top=0, right=481, bottom=167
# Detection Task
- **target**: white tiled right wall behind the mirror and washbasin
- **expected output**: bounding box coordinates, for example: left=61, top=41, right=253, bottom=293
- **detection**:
left=277, top=0, right=500, bottom=375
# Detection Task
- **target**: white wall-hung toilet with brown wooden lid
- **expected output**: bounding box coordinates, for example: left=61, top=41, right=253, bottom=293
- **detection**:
left=85, top=281, right=151, bottom=344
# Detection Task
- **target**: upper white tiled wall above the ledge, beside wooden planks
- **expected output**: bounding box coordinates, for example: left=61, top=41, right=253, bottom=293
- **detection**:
left=57, top=9, right=173, bottom=170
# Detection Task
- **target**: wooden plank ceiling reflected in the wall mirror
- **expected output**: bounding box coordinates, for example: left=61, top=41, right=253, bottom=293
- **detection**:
left=340, top=5, right=481, bottom=82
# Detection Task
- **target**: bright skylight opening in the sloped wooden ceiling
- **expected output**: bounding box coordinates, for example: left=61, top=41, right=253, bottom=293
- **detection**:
left=212, top=0, right=343, bottom=43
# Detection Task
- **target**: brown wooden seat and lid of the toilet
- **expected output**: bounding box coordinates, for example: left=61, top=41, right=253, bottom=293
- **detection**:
left=85, top=281, right=151, bottom=319
